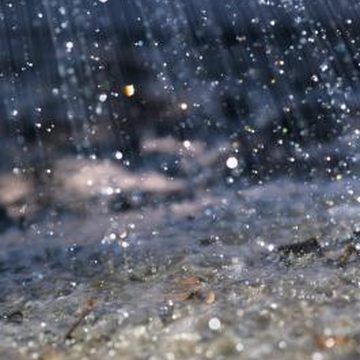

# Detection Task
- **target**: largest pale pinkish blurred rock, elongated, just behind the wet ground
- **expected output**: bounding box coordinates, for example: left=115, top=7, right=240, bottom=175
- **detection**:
left=53, top=158, right=186, bottom=211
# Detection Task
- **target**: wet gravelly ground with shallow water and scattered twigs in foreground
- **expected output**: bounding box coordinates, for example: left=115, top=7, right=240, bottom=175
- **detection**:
left=0, top=170, right=360, bottom=360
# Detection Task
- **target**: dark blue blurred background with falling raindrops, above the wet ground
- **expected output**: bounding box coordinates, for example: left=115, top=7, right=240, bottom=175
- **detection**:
left=0, top=0, right=360, bottom=226
